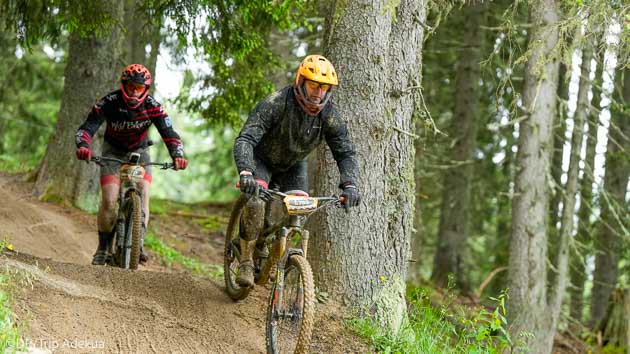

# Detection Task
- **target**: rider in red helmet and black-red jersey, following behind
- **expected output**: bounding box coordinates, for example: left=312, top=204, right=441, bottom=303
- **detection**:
left=76, top=64, right=188, bottom=265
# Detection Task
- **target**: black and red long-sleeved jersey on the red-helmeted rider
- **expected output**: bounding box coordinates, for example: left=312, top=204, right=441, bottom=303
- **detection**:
left=76, top=90, right=184, bottom=158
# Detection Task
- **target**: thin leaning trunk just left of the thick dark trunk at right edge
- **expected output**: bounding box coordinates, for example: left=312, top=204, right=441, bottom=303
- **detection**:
left=570, top=40, right=604, bottom=323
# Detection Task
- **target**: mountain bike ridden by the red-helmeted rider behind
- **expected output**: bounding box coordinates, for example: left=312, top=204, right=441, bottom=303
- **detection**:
left=90, top=152, right=174, bottom=269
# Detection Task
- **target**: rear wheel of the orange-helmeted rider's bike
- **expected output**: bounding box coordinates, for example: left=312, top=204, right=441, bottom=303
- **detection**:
left=223, top=195, right=251, bottom=300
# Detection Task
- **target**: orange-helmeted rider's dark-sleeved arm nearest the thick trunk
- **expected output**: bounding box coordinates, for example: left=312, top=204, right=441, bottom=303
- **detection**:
left=322, top=106, right=359, bottom=188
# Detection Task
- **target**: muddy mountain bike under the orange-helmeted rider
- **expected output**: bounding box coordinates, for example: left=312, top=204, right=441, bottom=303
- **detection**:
left=223, top=189, right=343, bottom=354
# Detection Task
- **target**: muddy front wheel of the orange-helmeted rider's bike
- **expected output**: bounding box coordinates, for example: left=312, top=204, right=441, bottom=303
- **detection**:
left=265, top=255, right=315, bottom=354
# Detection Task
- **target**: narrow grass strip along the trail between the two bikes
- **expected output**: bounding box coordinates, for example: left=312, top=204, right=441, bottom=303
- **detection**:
left=144, top=232, right=223, bottom=279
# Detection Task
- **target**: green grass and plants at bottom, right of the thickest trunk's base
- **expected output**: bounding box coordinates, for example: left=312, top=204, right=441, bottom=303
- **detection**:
left=349, top=288, right=527, bottom=354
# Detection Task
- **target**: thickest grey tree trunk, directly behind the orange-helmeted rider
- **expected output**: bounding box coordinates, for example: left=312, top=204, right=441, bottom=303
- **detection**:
left=311, top=0, right=425, bottom=329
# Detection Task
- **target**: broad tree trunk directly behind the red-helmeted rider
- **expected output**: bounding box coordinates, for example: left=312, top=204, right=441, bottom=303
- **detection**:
left=33, top=0, right=122, bottom=210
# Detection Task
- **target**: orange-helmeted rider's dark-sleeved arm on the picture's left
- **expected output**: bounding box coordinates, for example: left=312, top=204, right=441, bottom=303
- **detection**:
left=234, top=92, right=285, bottom=173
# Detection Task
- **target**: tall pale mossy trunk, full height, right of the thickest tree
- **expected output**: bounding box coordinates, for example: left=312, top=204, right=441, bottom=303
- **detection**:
left=508, top=0, right=559, bottom=353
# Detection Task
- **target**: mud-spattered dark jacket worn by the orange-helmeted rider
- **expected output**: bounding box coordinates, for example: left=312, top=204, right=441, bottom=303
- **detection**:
left=234, top=86, right=358, bottom=185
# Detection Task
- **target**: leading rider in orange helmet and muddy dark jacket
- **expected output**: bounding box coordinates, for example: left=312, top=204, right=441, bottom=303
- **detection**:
left=234, top=55, right=361, bottom=287
